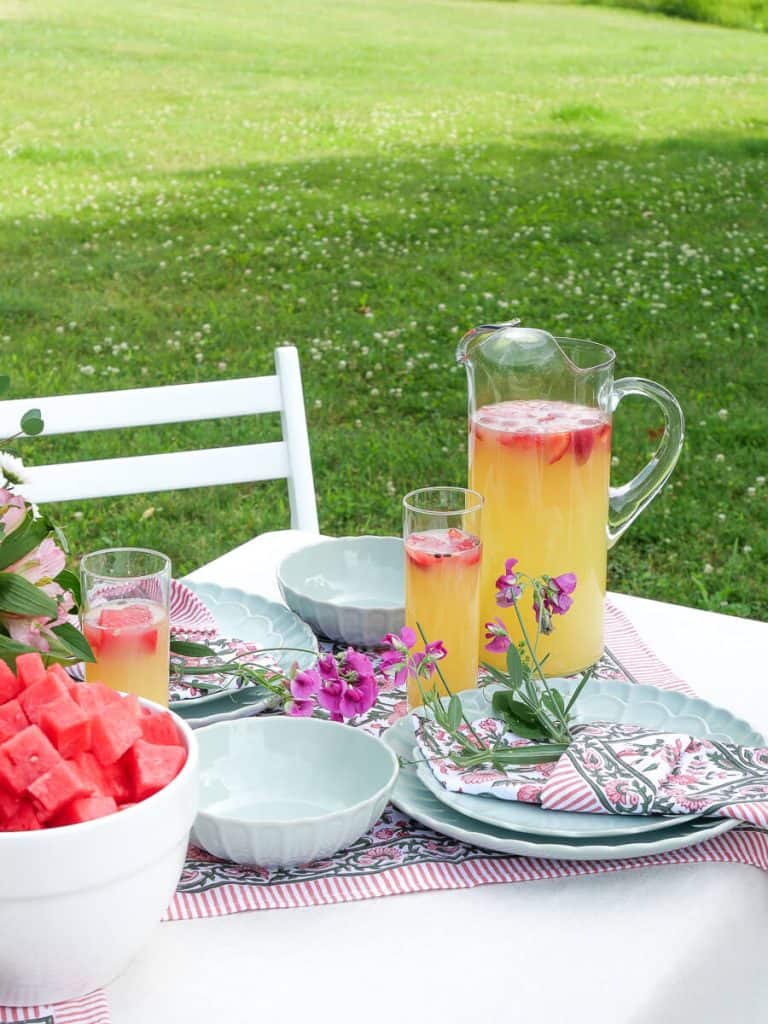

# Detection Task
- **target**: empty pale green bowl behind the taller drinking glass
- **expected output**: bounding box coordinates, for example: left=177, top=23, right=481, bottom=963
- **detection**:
left=278, top=537, right=406, bottom=646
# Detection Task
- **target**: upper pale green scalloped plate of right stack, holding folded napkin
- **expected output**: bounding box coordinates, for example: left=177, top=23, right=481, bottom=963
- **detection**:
left=417, top=679, right=764, bottom=839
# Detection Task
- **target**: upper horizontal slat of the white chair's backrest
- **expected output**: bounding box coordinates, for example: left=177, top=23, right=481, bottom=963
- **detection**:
left=0, top=376, right=283, bottom=437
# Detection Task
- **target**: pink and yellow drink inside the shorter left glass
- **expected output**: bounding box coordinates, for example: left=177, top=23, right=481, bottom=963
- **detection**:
left=83, top=600, right=169, bottom=706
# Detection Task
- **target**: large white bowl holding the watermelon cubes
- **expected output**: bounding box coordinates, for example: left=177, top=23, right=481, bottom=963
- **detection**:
left=0, top=700, right=198, bottom=1006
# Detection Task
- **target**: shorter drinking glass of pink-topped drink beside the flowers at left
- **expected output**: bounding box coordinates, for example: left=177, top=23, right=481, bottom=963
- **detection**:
left=80, top=548, right=171, bottom=705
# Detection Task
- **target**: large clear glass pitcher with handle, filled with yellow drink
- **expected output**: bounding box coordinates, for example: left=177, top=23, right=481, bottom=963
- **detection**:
left=457, top=321, right=684, bottom=676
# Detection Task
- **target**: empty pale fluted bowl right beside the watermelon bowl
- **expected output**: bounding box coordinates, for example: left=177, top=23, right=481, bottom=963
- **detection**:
left=193, top=715, right=398, bottom=867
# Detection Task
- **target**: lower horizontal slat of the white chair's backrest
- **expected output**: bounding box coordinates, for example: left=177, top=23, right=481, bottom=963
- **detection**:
left=23, top=441, right=289, bottom=503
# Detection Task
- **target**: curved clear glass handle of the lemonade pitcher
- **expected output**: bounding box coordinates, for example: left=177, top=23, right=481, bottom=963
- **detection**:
left=608, top=377, right=685, bottom=548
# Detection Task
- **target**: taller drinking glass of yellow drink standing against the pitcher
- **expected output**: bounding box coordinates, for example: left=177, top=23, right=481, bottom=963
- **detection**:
left=402, top=487, right=482, bottom=708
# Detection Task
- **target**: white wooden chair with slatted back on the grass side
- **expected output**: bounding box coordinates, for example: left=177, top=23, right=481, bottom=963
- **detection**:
left=0, top=346, right=318, bottom=532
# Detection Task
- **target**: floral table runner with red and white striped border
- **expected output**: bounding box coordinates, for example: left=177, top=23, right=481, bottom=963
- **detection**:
left=166, top=605, right=768, bottom=921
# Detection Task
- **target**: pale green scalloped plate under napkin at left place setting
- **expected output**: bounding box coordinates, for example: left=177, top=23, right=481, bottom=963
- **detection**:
left=170, top=580, right=317, bottom=727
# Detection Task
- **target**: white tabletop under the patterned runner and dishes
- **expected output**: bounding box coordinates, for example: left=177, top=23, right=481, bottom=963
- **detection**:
left=108, top=531, right=768, bottom=1024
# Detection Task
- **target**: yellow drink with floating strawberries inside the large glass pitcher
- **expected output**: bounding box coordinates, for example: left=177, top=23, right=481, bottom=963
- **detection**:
left=470, top=400, right=610, bottom=676
